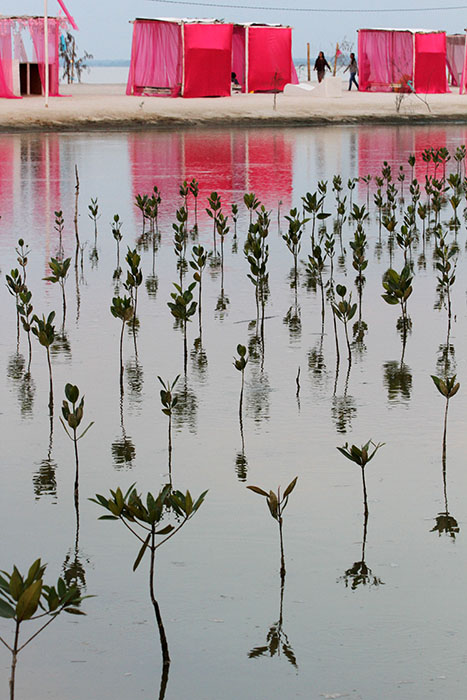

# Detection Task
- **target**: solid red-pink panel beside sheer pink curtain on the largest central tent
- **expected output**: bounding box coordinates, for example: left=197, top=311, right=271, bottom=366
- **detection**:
left=183, top=24, right=233, bottom=97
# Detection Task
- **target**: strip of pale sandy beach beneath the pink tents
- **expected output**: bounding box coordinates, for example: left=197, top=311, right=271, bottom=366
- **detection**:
left=0, top=84, right=467, bottom=131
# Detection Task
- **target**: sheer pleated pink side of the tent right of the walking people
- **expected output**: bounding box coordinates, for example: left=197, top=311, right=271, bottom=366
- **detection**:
left=358, top=29, right=413, bottom=92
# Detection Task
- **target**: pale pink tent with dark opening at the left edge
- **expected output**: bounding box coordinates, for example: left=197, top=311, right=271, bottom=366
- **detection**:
left=0, top=16, right=68, bottom=98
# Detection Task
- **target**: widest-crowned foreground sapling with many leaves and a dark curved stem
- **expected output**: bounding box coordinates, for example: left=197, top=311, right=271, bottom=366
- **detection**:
left=90, top=484, right=207, bottom=673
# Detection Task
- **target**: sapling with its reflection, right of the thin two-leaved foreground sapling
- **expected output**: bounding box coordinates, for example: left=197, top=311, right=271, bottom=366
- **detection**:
left=337, top=440, right=384, bottom=591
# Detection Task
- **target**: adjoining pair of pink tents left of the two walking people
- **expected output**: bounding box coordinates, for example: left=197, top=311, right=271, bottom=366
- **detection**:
left=126, top=19, right=298, bottom=97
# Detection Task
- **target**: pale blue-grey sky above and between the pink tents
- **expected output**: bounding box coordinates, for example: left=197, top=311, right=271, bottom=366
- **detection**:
left=5, top=0, right=467, bottom=59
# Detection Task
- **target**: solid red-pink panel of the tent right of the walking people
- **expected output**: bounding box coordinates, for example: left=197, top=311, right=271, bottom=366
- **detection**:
left=415, top=32, right=449, bottom=94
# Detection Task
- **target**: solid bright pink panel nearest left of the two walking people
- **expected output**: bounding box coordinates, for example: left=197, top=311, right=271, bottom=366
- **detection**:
left=247, top=27, right=296, bottom=92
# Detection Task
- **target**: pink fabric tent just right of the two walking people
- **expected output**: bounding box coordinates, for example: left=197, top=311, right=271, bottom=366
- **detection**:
left=358, top=29, right=449, bottom=94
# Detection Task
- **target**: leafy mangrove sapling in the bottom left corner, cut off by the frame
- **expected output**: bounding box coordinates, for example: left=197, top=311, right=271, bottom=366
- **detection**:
left=0, top=559, right=90, bottom=700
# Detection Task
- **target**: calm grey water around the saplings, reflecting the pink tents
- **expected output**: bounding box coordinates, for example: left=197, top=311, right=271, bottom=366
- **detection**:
left=0, top=127, right=467, bottom=700
